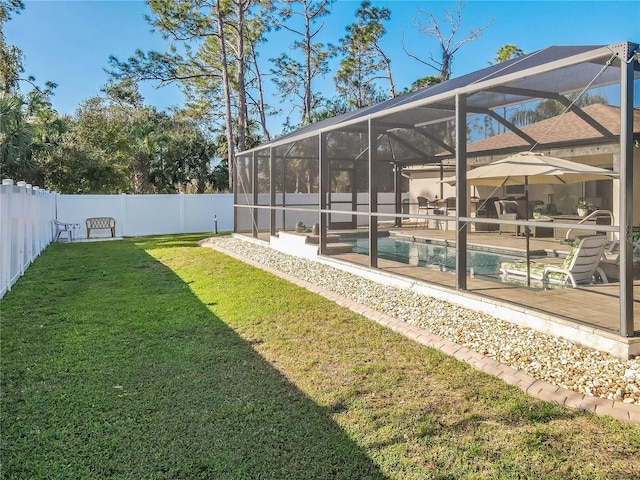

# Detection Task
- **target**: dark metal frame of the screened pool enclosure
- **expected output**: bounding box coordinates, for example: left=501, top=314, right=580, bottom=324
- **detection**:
left=234, top=42, right=640, bottom=337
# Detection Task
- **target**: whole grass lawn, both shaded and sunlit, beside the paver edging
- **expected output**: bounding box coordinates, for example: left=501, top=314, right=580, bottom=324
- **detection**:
left=0, top=235, right=640, bottom=480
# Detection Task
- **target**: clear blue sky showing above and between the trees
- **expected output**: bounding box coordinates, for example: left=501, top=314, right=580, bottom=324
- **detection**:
left=5, top=0, right=640, bottom=133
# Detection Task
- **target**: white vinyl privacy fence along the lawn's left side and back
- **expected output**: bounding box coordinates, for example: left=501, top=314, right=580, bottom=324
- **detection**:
left=0, top=180, right=233, bottom=298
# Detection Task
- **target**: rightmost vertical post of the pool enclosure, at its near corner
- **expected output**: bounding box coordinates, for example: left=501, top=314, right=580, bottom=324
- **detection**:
left=618, top=43, right=636, bottom=337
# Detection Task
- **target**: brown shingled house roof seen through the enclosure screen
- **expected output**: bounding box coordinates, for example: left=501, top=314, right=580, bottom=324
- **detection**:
left=467, top=103, right=640, bottom=153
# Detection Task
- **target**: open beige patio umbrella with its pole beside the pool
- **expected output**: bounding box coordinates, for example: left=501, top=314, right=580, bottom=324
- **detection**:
left=442, top=152, right=618, bottom=286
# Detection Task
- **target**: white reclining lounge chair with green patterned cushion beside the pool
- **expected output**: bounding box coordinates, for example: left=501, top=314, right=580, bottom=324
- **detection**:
left=500, top=235, right=608, bottom=288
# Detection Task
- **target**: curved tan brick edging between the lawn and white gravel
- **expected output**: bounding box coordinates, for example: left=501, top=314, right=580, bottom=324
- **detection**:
left=200, top=241, right=640, bottom=424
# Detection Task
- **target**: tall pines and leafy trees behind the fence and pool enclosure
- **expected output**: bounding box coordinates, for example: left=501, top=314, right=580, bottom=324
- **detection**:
left=0, top=0, right=500, bottom=193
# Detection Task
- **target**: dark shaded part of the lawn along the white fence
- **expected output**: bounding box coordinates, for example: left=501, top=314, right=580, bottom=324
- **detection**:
left=1, top=238, right=387, bottom=479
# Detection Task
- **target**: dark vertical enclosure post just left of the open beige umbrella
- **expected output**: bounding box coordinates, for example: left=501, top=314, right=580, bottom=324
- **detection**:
left=456, top=94, right=467, bottom=290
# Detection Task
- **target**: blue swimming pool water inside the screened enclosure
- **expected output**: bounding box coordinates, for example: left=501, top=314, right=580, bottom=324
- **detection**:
left=341, top=237, right=524, bottom=276
